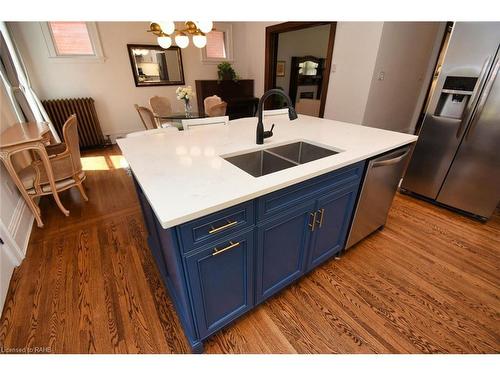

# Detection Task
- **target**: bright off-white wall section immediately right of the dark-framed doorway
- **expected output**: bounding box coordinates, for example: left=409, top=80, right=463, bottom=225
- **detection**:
left=324, top=22, right=384, bottom=124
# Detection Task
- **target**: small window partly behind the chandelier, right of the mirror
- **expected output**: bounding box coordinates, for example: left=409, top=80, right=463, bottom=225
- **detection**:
left=201, top=24, right=232, bottom=64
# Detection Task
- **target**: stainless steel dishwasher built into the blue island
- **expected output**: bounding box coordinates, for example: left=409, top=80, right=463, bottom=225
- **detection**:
left=346, top=145, right=411, bottom=249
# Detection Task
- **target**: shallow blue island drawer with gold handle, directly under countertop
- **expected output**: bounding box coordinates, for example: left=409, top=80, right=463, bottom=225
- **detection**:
left=179, top=201, right=254, bottom=252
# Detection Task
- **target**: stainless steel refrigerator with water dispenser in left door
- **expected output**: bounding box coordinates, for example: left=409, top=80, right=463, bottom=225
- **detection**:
left=401, top=22, right=500, bottom=219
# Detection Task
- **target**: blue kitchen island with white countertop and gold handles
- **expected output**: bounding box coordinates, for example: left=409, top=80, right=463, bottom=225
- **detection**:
left=118, top=115, right=416, bottom=352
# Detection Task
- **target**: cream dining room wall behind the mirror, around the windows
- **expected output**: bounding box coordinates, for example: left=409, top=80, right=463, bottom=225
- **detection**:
left=10, top=22, right=252, bottom=138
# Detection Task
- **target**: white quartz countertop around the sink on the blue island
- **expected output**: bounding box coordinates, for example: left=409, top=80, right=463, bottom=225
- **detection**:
left=117, top=115, right=417, bottom=228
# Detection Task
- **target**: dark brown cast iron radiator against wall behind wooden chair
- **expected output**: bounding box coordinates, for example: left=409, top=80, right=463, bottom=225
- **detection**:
left=42, top=98, right=106, bottom=148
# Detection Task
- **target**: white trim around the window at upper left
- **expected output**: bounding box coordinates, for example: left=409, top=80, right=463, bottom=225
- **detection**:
left=40, top=22, right=106, bottom=63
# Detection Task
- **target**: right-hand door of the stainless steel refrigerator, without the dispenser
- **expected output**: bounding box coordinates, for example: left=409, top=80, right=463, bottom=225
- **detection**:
left=437, top=47, right=500, bottom=218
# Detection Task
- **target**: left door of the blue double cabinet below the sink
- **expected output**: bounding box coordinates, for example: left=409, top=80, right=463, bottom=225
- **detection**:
left=256, top=204, right=314, bottom=303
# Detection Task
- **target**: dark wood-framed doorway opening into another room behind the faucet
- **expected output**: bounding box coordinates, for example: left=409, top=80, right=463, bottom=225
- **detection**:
left=265, top=22, right=337, bottom=117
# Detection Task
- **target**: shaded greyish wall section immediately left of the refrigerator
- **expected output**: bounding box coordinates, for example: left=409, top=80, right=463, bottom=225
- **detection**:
left=362, top=22, right=444, bottom=132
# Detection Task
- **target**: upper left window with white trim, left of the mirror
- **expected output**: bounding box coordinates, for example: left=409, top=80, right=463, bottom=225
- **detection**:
left=40, top=22, right=104, bottom=62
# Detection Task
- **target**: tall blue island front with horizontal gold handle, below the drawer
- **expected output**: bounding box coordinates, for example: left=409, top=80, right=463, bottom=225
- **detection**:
left=186, top=231, right=253, bottom=338
